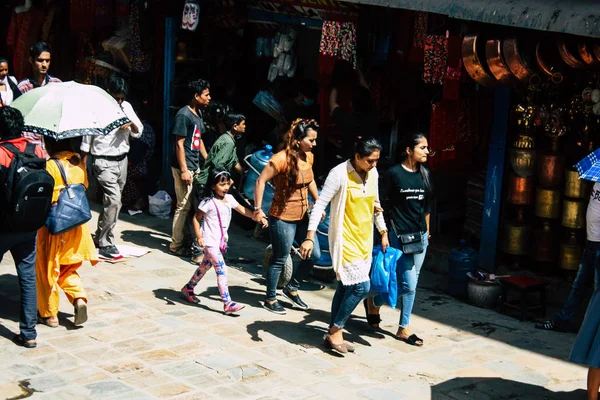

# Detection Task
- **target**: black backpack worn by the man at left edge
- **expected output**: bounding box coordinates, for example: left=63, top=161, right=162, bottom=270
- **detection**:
left=0, top=143, right=54, bottom=232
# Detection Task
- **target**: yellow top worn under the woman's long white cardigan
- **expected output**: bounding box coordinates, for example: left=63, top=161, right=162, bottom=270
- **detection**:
left=342, top=171, right=377, bottom=268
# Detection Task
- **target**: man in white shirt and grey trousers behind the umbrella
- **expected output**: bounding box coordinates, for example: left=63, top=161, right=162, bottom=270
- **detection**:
left=81, top=76, right=143, bottom=258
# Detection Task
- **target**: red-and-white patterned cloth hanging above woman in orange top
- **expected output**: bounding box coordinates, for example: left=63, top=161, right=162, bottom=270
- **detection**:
left=319, top=21, right=356, bottom=68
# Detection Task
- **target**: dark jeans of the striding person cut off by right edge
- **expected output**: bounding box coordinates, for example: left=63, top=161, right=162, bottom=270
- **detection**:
left=555, top=242, right=600, bottom=325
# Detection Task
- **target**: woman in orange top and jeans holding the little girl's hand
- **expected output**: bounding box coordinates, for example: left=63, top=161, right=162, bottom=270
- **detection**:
left=254, top=119, right=321, bottom=314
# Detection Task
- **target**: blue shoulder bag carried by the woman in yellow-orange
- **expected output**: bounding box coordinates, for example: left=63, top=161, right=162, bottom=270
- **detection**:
left=46, top=158, right=92, bottom=235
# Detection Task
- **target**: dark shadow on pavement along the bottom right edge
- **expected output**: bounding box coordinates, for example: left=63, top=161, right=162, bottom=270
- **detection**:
left=431, top=377, right=587, bottom=400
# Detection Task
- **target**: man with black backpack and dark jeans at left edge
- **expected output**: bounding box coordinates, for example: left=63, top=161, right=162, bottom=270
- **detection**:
left=0, top=107, right=54, bottom=348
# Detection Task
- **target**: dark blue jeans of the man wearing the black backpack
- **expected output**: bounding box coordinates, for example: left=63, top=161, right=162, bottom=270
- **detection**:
left=0, top=232, right=37, bottom=340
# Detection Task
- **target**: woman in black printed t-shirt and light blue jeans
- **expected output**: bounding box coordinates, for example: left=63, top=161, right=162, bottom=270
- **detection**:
left=364, top=133, right=432, bottom=346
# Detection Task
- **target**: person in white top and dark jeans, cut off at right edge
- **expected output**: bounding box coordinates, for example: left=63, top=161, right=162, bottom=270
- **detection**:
left=535, top=182, right=600, bottom=331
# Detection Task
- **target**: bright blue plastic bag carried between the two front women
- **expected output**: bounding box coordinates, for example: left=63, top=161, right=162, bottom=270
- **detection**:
left=371, top=245, right=402, bottom=308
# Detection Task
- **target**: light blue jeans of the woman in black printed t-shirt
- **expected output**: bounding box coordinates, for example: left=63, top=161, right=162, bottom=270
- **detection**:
left=374, top=232, right=429, bottom=328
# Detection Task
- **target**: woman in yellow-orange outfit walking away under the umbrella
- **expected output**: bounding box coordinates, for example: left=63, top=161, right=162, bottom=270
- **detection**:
left=36, top=139, right=98, bottom=328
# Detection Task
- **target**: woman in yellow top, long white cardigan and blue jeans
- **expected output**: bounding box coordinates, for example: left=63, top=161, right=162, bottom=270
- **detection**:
left=300, top=138, right=388, bottom=354
